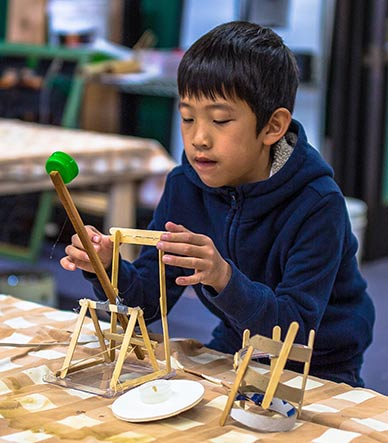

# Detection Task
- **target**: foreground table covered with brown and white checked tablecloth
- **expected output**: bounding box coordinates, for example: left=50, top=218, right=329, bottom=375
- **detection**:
left=0, top=295, right=388, bottom=443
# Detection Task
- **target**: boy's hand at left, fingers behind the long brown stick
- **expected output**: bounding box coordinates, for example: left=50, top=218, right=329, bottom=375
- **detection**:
left=60, top=226, right=113, bottom=273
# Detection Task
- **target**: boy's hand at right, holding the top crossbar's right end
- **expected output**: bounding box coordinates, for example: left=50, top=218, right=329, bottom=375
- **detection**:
left=157, top=222, right=232, bottom=292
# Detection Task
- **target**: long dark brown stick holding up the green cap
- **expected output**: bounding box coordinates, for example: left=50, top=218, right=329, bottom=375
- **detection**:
left=50, top=171, right=128, bottom=330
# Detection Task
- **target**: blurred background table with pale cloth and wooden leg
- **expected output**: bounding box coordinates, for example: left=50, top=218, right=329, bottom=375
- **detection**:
left=0, top=119, right=175, bottom=258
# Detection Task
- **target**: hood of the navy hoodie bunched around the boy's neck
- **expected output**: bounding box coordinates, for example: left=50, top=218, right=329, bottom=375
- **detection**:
left=182, top=120, right=334, bottom=215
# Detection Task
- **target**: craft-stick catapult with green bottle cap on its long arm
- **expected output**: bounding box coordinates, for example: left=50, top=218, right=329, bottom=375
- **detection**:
left=46, top=152, right=171, bottom=394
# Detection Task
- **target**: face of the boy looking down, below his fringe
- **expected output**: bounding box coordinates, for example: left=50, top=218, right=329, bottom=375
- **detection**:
left=179, top=97, right=270, bottom=187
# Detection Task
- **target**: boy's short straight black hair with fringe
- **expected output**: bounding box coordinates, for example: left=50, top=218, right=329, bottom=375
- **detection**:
left=178, top=21, right=298, bottom=134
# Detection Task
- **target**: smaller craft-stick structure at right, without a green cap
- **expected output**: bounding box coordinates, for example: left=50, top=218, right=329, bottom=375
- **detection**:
left=220, top=321, right=315, bottom=431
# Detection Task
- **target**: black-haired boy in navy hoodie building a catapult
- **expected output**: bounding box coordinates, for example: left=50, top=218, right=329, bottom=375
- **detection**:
left=61, top=22, right=374, bottom=386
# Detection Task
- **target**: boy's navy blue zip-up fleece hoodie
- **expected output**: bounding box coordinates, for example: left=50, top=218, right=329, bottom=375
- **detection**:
left=87, top=121, right=374, bottom=385
